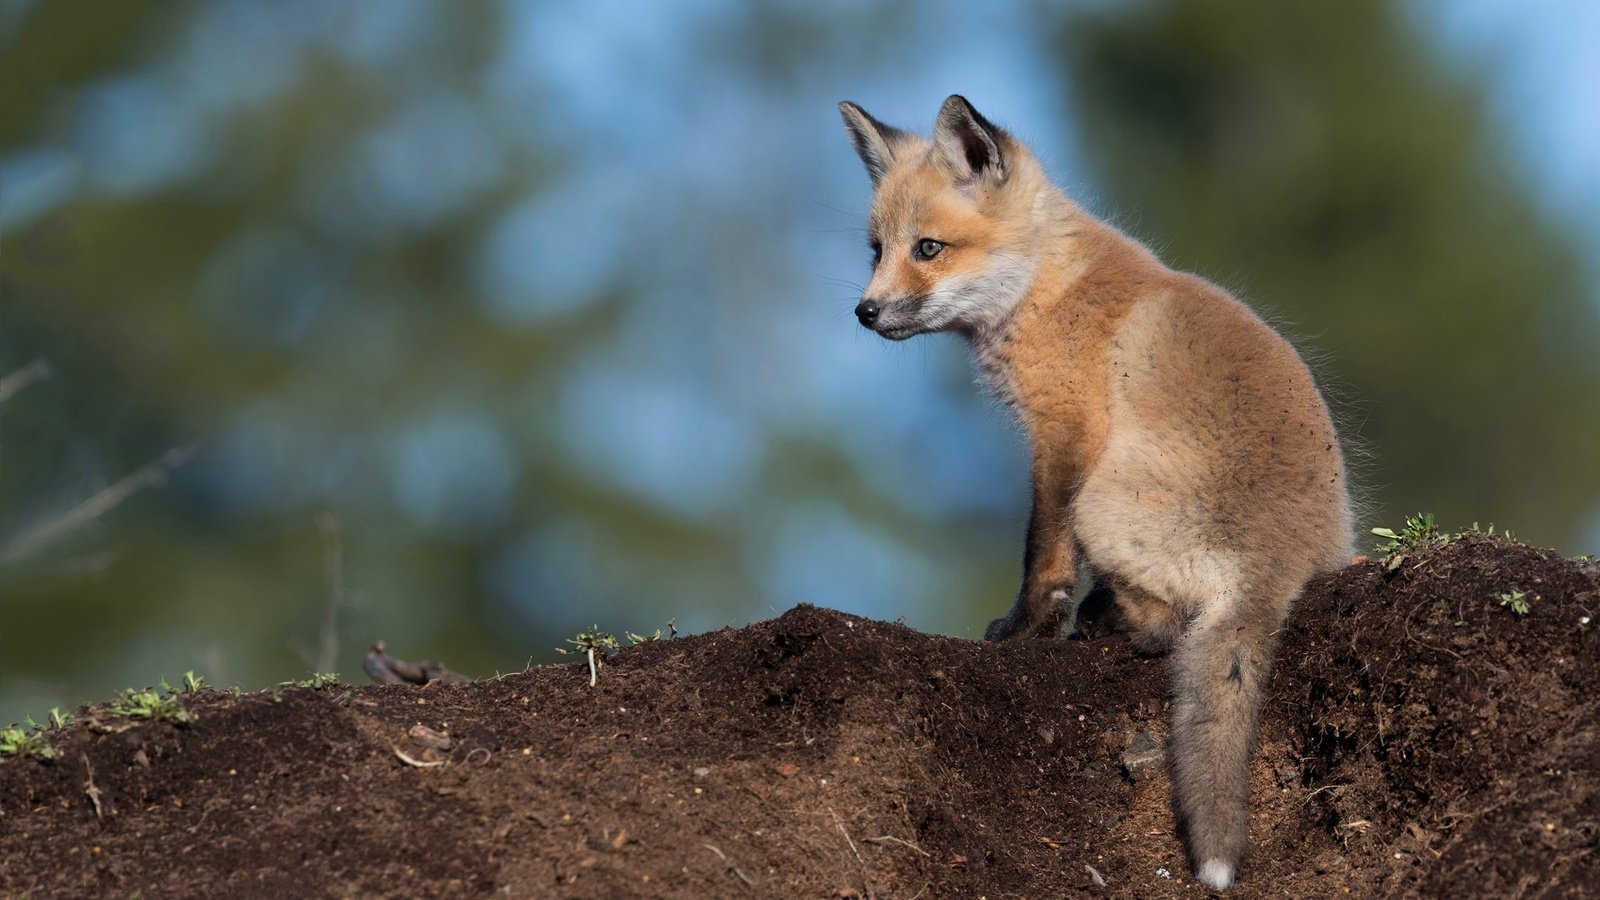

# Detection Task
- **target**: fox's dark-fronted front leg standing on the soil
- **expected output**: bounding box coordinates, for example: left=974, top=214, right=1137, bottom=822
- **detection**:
left=984, top=461, right=1078, bottom=641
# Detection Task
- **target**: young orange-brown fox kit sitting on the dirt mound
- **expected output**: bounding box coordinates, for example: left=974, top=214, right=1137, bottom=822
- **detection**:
left=838, top=94, right=1354, bottom=890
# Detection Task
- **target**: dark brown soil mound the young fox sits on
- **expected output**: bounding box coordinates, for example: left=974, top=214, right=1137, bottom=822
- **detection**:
left=0, top=538, right=1600, bottom=898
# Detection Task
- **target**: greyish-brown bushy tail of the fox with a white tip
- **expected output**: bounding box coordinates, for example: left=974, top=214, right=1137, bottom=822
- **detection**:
left=1171, top=607, right=1282, bottom=890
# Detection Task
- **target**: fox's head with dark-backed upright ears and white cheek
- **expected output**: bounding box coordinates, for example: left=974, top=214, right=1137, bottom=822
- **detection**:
left=838, top=96, right=1046, bottom=341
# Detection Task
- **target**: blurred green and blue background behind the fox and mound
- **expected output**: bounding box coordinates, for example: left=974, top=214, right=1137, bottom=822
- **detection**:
left=0, top=0, right=1600, bottom=722
